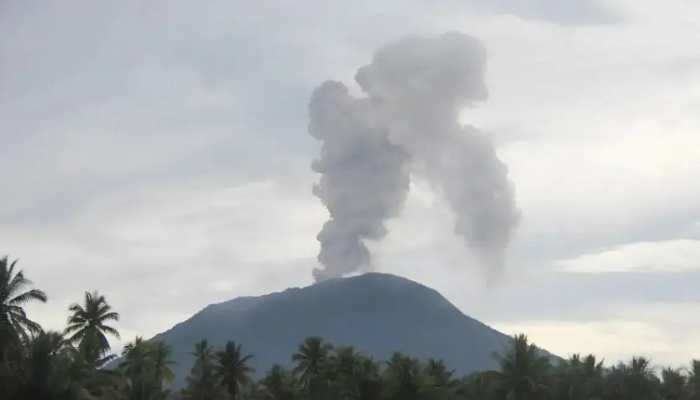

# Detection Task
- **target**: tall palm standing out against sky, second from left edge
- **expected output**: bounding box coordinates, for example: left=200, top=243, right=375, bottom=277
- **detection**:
left=64, top=292, right=120, bottom=367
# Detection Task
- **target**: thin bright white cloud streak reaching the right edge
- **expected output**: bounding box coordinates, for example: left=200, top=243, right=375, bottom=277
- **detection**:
left=552, top=239, right=700, bottom=273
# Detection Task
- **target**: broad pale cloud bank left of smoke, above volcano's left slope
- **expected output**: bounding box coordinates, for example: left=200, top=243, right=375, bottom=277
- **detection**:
left=13, top=180, right=326, bottom=350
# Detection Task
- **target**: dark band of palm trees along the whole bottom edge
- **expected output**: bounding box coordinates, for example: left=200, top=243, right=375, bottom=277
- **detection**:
left=0, top=257, right=700, bottom=400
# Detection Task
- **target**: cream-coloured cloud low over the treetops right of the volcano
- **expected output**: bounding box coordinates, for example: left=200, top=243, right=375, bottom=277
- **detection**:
left=492, top=301, right=700, bottom=367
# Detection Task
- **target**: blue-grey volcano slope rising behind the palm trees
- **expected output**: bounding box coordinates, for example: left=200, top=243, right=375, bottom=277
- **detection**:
left=155, top=273, right=520, bottom=387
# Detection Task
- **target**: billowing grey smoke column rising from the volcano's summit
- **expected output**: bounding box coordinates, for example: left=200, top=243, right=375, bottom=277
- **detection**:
left=309, top=32, right=520, bottom=281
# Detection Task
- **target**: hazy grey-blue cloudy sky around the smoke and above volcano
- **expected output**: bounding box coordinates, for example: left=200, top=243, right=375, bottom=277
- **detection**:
left=0, top=0, right=700, bottom=366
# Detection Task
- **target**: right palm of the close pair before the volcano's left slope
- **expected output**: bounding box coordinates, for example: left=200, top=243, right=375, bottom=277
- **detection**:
left=214, top=341, right=255, bottom=400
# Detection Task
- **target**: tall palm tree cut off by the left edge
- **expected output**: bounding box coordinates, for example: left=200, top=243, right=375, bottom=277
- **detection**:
left=0, top=257, right=47, bottom=356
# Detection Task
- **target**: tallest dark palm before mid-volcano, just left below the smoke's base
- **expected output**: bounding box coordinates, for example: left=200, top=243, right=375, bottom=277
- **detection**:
left=292, top=336, right=333, bottom=397
